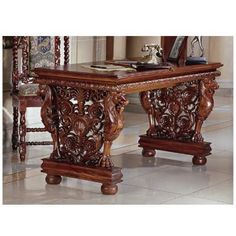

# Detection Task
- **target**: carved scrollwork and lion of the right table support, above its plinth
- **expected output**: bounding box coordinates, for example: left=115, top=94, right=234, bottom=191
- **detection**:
left=140, top=78, right=218, bottom=142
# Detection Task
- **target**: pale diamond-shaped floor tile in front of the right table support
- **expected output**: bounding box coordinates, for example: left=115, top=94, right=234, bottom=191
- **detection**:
left=126, top=166, right=231, bottom=194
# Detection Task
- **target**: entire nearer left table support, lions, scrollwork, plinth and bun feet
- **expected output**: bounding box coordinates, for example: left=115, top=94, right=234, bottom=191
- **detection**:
left=41, top=85, right=127, bottom=194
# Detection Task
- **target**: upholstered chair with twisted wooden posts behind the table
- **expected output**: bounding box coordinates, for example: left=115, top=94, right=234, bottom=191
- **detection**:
left=11, top=36, right=69, bottom=161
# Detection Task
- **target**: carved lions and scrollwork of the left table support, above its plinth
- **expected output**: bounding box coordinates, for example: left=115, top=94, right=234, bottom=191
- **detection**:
left=41, top=86, right=127, bottom=168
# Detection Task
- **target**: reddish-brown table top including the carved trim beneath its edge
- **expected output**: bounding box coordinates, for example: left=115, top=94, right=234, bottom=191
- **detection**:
left=34, top=61, right=223, bottom=92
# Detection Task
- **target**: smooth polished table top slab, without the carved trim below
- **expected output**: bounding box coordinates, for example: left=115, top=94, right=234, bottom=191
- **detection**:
left=34, top=61, right=222, bottom=82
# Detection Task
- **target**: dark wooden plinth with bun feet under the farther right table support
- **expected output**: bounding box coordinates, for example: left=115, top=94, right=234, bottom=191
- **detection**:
left=139, top=135, right=211, bottom=165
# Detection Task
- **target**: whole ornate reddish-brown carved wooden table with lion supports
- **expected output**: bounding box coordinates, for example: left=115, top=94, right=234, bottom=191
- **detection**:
left=35, top=63, right=222, bottom=194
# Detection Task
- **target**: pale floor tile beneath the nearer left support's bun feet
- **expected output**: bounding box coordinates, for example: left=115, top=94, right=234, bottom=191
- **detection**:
left=3, top=175, right=179, bottom=204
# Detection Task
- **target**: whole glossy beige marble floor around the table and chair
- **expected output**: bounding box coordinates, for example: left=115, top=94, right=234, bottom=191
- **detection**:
left=3, top=96, right=233, bottom=204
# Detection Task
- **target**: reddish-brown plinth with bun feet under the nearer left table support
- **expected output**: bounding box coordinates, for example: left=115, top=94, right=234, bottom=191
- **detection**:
left=41, top=158, right=123, bottom=195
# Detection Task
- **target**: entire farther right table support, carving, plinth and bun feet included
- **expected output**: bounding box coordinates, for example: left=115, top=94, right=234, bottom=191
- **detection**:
left=139, top=78, right=218, bottom=165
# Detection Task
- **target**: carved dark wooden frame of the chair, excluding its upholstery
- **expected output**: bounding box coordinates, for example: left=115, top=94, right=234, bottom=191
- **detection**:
left=11, top=36, right=69, bottom=161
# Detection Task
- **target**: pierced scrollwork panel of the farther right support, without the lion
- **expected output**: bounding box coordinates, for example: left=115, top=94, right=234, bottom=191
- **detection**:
left=140, top=81, right=199, bottom=140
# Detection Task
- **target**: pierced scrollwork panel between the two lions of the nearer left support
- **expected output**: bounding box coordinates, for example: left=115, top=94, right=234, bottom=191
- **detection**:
left=53, top=86, right=106, bottom=166
